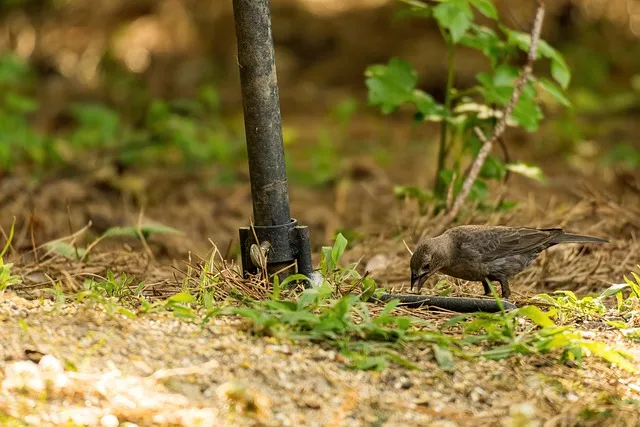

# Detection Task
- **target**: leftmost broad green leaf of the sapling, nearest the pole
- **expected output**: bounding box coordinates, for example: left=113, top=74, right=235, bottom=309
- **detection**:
left=365, top=58, right=418, bottom=114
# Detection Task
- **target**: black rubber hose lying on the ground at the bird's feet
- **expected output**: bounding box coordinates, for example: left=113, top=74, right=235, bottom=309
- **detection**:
left=373, top=294, right=517, bottom=313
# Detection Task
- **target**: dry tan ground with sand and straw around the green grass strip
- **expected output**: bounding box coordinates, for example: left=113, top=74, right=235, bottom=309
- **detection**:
left=0, top=115, right=640, bottom=426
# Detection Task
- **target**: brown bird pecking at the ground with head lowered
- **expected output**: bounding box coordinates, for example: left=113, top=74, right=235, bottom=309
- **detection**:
left=411, top=225, right=609, bottom=299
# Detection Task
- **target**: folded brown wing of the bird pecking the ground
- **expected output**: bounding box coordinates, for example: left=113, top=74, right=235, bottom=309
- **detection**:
left=462, top=227, right=563, bottom=262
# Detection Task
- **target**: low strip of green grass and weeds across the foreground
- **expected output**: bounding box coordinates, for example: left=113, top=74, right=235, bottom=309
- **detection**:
left=31, top=234, right=640, bottom=372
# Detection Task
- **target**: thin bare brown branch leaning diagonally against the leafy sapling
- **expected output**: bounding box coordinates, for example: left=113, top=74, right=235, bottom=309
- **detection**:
left=449, top=0, right=544, bottom=221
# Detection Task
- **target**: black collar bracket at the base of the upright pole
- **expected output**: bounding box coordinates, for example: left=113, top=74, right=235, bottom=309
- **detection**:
left=239, top=218, right=313, bottom=278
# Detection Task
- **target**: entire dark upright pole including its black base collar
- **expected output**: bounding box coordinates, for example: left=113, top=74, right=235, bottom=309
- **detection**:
left=233, top=0, right=313, bottom=285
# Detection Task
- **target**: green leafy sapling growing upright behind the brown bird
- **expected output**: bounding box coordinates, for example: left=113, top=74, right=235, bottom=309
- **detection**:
left=365, top=0, right=571, bottom=211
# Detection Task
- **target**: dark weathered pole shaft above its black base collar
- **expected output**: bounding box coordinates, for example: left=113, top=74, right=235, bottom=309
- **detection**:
left=233, top=0, right=291, bottom=226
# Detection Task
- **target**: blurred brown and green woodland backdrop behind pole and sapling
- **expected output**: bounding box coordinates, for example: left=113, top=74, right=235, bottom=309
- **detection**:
left=0, top=0, right=640, bottom=257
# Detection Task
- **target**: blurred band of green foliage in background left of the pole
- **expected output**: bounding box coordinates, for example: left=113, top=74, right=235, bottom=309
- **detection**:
left=0, top=54, right=245, bottom=182
